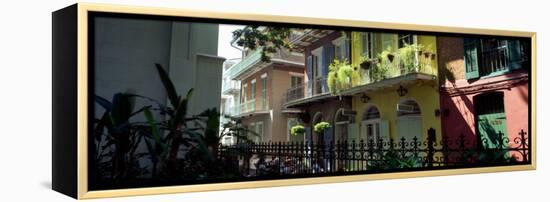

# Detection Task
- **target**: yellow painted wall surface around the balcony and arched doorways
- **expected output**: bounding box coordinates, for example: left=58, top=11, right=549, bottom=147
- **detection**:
left=350, top=32, right=441, bottom=140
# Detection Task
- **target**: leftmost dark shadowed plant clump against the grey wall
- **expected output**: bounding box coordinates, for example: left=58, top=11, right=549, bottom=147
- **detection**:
left=91, top=93, right=150, bottom=183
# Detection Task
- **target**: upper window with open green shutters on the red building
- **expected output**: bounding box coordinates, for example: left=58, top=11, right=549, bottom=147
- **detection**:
left=464, top=38, right=528, bottom=79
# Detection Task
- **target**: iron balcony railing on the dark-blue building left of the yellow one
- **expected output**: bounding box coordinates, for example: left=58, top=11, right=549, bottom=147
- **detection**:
left=285, top=77, right=330, bottom=103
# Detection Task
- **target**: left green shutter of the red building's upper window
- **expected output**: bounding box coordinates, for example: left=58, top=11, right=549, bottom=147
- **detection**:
left=464, top=38, right=479, bottom=79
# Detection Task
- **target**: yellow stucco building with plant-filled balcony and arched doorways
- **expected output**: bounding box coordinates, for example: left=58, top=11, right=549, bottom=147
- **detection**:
left=341, top=32, right=441, bottom=142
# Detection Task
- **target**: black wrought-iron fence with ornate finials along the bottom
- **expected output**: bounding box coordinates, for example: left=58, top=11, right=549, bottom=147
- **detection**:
left=218, top=130, right=530, bottom=176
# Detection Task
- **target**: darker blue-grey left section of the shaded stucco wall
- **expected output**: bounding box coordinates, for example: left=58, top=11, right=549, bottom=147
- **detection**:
left=93, top=17, right=172, bottom=120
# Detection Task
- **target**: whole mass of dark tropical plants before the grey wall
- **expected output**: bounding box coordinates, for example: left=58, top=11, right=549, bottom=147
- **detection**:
left=90, top=64, right=254, bottom=186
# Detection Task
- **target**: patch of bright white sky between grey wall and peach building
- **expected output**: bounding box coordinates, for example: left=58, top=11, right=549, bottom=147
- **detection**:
left=218, top=24, right=244, bottom=64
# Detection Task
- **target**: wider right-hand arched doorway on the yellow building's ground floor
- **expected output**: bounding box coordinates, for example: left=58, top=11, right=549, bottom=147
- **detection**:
left=396, top=100, right=424, bottom=141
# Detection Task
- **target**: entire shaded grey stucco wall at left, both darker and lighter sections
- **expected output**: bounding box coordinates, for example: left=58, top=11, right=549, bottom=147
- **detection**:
left=94, top=17, right=223, bottom=120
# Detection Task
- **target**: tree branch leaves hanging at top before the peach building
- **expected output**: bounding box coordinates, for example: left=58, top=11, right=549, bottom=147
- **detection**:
left=233, top=25, right=291, bottom=62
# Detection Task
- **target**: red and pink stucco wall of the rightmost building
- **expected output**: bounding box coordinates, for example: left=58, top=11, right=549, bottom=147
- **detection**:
left=437, top=37, right=529, bottom=145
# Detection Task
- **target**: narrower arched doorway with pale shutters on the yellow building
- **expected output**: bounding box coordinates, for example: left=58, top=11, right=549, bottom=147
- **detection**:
left=360, top=105, right=382, bottom=146
